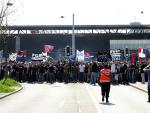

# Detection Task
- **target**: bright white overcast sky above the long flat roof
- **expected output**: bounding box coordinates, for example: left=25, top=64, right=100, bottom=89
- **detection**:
left=11, top=0, right=150, bottom=25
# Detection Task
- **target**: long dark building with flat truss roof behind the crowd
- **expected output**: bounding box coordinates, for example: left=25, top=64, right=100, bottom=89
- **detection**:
left=0, top=24, right=150, bottom=58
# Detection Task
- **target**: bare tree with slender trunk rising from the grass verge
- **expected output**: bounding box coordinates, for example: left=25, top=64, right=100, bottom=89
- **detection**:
left=0, top=0, right=22, bottom=83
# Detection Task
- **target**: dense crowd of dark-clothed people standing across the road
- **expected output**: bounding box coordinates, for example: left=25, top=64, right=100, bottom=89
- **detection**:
left=0, top=61, right=147, bottom=85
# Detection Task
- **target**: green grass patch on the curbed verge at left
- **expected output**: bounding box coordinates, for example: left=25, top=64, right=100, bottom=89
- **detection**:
left=0, top=78, right=21, bottom=93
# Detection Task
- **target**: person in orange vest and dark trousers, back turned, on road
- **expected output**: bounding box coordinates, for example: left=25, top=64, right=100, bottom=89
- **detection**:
left=99, top=64, right=111, bottom=103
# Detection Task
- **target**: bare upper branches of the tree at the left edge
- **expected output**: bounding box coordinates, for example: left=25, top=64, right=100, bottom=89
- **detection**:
left=0, top=0, right=23, bottom=31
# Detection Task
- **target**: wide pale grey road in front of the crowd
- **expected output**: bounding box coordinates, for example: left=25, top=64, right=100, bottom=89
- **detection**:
left=0, top=83, right=150, bottom=113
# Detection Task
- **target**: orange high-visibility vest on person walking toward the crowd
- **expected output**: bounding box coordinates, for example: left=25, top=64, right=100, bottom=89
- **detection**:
left=100, top=69, right=110, bottom=83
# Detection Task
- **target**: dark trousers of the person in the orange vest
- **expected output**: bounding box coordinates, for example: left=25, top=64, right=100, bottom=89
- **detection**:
left=101, top=82, right=110, bottom=99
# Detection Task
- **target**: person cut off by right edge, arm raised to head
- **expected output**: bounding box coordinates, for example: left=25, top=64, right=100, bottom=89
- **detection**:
left=143, top=63, right=150, bottom=102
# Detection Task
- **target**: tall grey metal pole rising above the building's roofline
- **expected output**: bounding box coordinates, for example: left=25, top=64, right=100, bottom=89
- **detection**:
left=72, top=13, right=76, bottom=55
